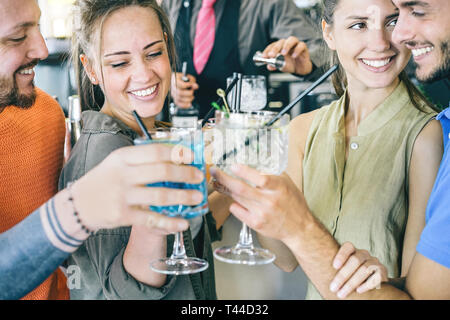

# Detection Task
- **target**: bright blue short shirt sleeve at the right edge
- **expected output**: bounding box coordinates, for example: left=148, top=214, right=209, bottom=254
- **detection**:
left=417, top=109, right=450, bottom=268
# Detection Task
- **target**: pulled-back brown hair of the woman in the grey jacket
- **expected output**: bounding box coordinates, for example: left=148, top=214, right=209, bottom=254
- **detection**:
left=71, top=0, right=176, bottom=110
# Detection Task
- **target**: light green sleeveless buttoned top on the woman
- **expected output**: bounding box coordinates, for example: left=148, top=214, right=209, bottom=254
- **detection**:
left=303, top=82, right=435, bottom=299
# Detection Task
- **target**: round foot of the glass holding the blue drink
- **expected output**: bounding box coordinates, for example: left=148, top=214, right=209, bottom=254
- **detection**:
left=150, top=258, right=208, bottom=275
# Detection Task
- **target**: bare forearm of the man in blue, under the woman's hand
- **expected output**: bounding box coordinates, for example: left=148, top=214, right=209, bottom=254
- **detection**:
left=285, top=214, right=410, bottom=300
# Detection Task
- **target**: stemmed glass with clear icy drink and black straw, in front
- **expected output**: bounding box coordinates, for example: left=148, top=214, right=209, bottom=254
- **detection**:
left=212, top=111, right=290, bottom=265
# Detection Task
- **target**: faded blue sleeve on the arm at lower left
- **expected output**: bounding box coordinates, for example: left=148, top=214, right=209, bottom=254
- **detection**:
left=0, top=204, right=70, bottom=300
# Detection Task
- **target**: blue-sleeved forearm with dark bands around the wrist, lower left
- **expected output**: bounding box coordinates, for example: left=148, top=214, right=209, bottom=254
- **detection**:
left=0, top=192, right=86, bottom=299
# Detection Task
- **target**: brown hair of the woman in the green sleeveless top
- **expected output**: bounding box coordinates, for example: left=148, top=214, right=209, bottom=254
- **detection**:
left=321, top=0, right=440, bottom=113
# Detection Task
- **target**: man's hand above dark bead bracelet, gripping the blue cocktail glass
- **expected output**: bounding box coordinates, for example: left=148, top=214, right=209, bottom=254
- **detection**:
left=72, top=144, right=204, bottom=234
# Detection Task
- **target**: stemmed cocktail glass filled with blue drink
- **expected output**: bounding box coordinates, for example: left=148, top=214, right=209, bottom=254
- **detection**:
left=134, top=128, right=209, bottom=275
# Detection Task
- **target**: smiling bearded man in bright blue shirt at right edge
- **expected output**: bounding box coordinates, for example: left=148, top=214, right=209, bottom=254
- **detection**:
left=213, top=0, right=450, bottom=299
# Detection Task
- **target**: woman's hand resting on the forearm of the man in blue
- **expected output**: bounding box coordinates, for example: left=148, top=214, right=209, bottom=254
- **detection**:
left=330, top=242, right=388, bottom=299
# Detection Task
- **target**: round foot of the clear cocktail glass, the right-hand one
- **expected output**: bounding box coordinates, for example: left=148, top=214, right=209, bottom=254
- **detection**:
left=214, top=246, right=276, bottom=266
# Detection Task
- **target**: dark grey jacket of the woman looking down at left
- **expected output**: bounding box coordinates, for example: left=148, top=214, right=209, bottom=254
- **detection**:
left=59, top=111, right=220, bottom=300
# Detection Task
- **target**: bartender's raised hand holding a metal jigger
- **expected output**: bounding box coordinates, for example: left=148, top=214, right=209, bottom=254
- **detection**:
left=262, top=36, right=313, bottom=76
